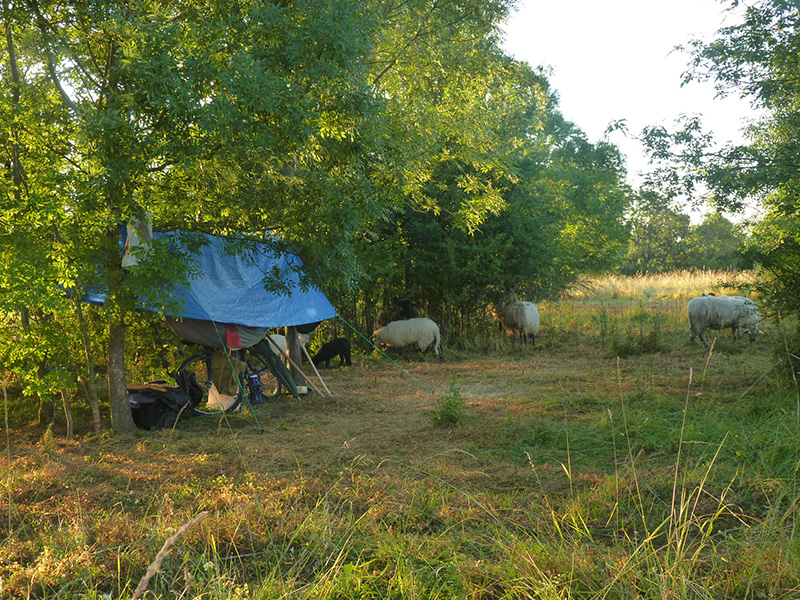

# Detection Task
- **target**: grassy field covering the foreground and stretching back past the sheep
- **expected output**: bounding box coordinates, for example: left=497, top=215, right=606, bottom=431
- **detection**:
left=0, top=273, right=800, bottom=599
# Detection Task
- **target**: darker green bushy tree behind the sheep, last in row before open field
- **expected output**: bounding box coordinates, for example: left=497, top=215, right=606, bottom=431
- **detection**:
left=354, top=61, right=628, bottom=330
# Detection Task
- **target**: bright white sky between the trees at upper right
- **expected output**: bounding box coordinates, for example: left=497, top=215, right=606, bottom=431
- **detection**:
left=503, top=0, right=754, bottom=185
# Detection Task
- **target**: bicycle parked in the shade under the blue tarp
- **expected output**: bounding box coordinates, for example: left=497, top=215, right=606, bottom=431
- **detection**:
left=173, top=347, right=281, bottom=415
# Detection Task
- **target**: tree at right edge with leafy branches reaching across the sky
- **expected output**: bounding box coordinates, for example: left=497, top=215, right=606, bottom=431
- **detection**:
left=645, top=0, right=800, bottom=314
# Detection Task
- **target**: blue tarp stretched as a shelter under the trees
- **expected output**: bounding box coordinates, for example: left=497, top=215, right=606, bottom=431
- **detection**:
left=86, top=232, right=336, bottom=327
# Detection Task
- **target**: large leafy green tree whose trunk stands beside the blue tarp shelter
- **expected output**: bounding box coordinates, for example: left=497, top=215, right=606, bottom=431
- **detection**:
left=3, top=0, right=388, bottom=433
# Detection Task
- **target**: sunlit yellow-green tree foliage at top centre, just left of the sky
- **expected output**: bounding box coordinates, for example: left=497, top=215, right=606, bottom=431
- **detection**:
left=369, top=0, right=516, bottom=231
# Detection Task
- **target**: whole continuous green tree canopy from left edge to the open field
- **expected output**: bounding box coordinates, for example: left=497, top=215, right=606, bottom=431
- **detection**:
left=0, top=0, right=628, bottom=431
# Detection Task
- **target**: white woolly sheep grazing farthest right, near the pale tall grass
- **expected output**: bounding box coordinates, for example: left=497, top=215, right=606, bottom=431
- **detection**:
left=686, top=294, right=764, bottom=348
